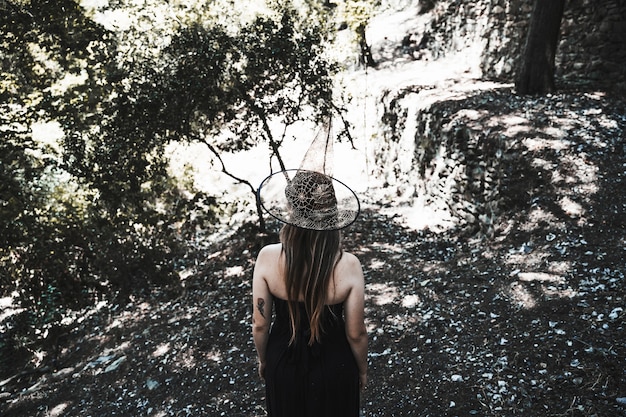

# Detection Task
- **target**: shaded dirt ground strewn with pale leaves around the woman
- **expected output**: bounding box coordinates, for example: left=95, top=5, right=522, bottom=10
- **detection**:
left=0, top=82, right=626, bottom=417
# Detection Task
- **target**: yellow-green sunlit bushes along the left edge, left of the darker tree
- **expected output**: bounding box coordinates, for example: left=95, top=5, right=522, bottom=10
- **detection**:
left=0, top=1, right=215, bottom=334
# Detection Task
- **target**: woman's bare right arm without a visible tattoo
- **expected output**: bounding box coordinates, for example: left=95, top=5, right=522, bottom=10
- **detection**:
left=344, top=256, right=367, bottom=389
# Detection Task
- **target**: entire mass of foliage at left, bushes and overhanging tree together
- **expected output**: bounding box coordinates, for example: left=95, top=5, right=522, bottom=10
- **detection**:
left=0, top=0, right=333, bottom=364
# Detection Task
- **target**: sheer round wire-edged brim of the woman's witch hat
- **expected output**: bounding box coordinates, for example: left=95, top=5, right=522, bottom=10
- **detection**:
left=257, top=169, right=361, bottom=231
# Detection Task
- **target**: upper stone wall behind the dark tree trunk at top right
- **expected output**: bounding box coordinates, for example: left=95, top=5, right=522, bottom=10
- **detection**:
left=388, top=0, right=626, bottom=96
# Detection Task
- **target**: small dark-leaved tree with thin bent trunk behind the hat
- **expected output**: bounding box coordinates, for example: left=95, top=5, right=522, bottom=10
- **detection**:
left=158, top=6, right=342, bottom=230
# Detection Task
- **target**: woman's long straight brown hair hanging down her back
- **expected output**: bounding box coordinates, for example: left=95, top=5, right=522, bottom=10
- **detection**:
left=280, top=224, right=342, bottom=345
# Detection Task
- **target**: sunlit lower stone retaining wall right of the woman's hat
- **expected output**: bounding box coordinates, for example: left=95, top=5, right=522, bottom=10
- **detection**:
left=375, top=83, right=508, bottom=235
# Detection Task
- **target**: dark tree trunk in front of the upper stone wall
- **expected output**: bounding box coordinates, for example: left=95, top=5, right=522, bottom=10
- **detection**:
left=515, top=0, right=565, bottom=94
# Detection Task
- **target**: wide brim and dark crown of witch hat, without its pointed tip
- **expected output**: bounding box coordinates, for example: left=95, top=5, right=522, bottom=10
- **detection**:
left=257, top=169, right=361, bottom=231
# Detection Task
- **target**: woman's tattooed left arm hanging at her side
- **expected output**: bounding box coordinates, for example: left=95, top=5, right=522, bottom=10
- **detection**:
left=252, top=248, right=274, bottom=378
